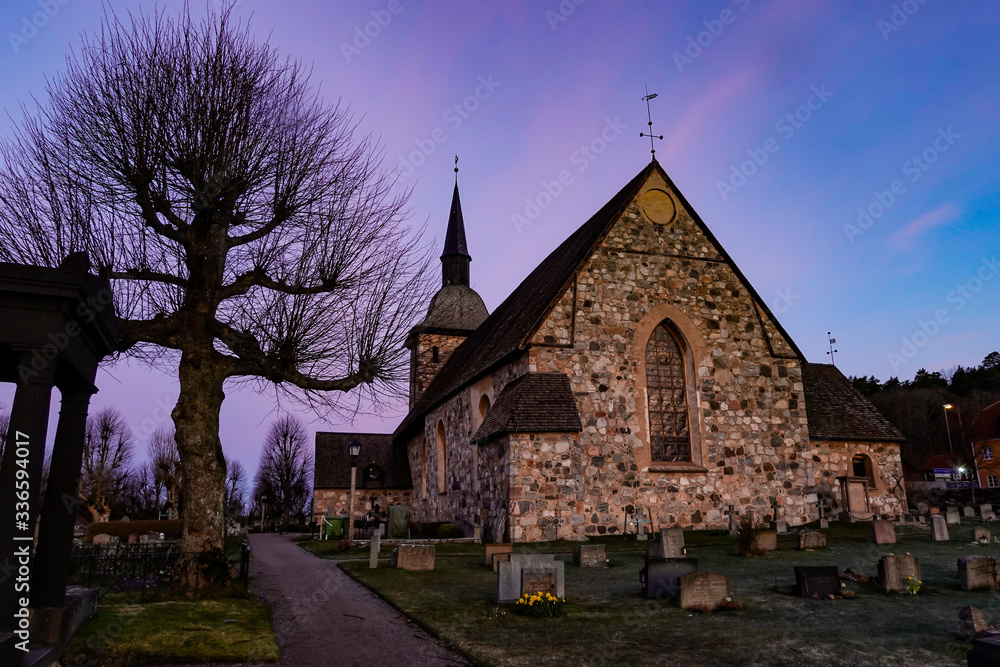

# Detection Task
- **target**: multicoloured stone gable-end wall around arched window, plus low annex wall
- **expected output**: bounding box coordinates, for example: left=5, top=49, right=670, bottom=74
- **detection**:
left=510, top=181, right=899, bottom=541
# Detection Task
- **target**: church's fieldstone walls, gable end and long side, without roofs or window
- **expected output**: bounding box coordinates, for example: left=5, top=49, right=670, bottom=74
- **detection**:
left=400, top=167, right=902, bottom=542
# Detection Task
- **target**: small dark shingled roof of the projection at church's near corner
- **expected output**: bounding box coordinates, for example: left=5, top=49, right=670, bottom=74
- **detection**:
left=472, top=373, right=583, bottom=445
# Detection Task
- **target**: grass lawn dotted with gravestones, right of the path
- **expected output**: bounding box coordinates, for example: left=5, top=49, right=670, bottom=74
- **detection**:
left=334, top=518, right=1000, bottom=667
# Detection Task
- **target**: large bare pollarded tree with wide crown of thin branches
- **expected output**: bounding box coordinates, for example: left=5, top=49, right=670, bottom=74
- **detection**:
left=0, top=7, right=428, bottom=589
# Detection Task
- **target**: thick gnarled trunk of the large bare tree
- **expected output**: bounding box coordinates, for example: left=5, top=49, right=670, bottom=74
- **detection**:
left=172, top=351, right=229, bottom=596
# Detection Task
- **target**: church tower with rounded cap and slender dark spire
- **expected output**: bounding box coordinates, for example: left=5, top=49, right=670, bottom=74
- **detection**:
left=406, top=167, right=489, bottom=407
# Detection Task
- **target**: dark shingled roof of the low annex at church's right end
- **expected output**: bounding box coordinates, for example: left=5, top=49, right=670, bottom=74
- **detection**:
left=802, top=362, right=906, bottom=442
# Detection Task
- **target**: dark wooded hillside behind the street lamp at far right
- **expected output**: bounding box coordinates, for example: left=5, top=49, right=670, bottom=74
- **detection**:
left=849, top=351, right=1000, bottom=468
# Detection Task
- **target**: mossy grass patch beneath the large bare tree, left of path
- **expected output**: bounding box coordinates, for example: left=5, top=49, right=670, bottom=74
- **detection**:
left=60, top=594, right=279, bottom=667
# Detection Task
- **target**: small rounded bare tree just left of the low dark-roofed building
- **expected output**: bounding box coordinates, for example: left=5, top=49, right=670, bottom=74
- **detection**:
left=254, top=416, right=313, bottom=528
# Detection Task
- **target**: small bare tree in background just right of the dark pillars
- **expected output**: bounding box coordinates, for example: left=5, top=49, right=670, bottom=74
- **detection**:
left=80, top=408, right=135, bottom=521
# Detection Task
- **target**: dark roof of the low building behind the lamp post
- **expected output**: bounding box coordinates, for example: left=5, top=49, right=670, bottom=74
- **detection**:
left=313, top=431, right=411, bottom=489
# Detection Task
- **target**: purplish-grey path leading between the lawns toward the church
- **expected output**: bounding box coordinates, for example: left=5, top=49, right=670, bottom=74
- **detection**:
left=188, top=534, right=468, bottom=667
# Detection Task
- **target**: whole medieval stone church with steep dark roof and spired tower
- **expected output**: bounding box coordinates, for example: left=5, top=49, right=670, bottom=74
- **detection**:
left=317, top=160, right=905, bottom=542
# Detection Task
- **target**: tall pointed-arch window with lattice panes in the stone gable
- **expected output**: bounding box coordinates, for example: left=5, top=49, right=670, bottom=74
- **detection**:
left=646, top=320, right=691, bottom=462
